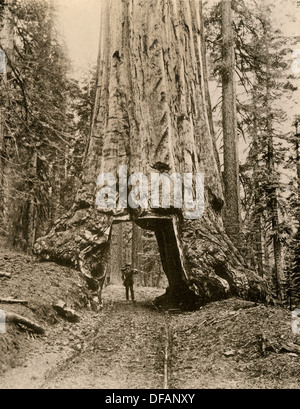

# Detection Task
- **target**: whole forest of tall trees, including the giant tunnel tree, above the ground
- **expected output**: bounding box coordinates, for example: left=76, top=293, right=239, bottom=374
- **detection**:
left=0, top=0, right=300, bottom=388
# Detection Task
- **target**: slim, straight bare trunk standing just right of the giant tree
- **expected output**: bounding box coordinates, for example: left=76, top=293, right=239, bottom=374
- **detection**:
left=222, top=0, right=241, bottom=247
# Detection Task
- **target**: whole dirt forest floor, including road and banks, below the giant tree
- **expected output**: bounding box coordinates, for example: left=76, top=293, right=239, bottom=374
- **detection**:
left=0, top=242, right=300, bottom=389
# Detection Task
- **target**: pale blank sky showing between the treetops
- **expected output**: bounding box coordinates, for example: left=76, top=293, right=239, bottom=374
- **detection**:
left=53, top=0, right=300, bottom=171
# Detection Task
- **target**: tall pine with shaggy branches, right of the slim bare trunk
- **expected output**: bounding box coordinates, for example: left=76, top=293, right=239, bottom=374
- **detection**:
left=207, top=0, right=293, bottom=300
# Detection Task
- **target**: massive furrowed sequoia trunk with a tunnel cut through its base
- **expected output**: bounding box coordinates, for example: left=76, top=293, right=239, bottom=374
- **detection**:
left=35, top=0, right=266, bottom=308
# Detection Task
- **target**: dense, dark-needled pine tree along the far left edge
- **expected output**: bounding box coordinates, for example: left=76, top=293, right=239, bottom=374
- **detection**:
left=2, top=0, right=77, bottom=250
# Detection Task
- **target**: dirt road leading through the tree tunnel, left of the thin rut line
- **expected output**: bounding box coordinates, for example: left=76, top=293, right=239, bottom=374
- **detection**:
left=0, top=287, right=169, bottom=389
